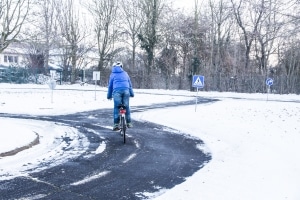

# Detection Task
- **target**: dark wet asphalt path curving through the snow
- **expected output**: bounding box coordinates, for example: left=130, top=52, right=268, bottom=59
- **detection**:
left=0, top=98, right=215, bottom=200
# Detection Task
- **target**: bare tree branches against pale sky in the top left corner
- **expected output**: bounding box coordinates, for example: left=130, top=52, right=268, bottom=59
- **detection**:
left=0, top=0, right=29, bottom=53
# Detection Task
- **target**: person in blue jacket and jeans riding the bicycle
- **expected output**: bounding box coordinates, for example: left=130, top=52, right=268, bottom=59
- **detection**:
left=107, top=62, right=134, bottom=131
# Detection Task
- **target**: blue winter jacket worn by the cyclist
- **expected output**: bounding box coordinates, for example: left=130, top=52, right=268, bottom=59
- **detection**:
left=107, top=66, right=134, bottom=99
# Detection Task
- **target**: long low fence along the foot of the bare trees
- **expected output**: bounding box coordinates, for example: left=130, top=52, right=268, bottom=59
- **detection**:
left=0, top=67, right=300, bottom=94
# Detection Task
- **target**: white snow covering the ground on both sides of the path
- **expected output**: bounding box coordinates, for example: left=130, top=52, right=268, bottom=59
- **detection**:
left=0, top=83, right=300, bottom=200
